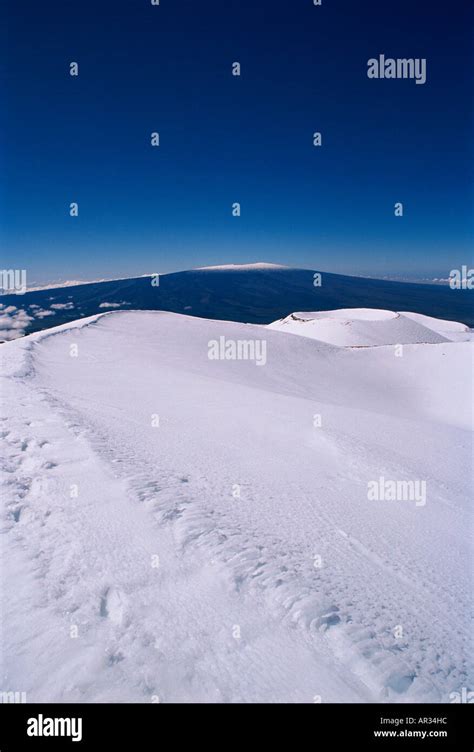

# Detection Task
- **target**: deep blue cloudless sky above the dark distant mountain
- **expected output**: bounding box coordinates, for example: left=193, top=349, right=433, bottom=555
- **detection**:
left=0, top=0, right=473, bottom=282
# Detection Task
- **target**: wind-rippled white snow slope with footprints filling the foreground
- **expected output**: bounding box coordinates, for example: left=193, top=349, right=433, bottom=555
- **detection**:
left=0, top=312, right=472, bottom=703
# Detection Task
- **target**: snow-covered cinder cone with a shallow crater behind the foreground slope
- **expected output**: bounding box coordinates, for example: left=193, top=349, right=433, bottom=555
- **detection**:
left=268, top=308, right=472, bottom=347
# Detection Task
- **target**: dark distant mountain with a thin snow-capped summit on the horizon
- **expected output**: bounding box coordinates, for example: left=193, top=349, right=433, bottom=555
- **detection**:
left=0, top=263, right=474, bottom=339
